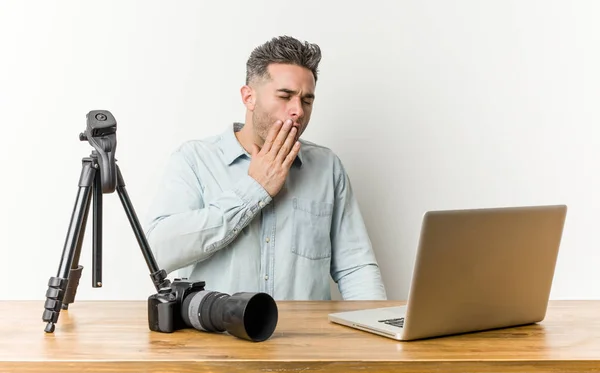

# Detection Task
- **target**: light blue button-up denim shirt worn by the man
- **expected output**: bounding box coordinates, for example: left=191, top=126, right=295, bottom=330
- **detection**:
left=145, top=124, right=386, bottom=300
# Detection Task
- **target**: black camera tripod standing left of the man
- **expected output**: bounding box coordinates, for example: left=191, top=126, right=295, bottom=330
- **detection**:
left=42, top=110, right=170, bottom=333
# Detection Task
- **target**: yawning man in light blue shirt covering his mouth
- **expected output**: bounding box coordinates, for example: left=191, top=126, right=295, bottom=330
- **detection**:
left=146, top=33, right=386, bottom=300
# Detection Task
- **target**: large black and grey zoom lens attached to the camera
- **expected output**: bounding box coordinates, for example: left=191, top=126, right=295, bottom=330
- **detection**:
left=181, top=290, right=278, bottom=342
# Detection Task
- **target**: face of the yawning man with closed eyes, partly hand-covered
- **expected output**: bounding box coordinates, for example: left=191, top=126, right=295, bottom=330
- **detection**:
left=252, top=64, right=315, bottom=146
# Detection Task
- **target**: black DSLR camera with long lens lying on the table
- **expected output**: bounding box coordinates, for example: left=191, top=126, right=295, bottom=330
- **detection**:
left=148, top=278, right=278, bottom=342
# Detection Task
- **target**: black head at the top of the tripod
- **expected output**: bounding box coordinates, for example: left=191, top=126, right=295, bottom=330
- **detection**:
left=79, top=110, right=117, bottom=193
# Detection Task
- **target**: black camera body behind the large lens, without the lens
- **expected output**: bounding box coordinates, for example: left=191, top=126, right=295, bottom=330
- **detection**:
left=148, top=278, right=205, bottom=333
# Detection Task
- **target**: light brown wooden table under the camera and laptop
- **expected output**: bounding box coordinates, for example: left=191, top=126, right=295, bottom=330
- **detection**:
left=0, top=301, right=600, bottom=372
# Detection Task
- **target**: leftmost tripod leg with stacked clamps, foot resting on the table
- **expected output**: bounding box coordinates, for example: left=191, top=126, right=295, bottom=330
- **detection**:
left=42, top=159, right=96, bottom=333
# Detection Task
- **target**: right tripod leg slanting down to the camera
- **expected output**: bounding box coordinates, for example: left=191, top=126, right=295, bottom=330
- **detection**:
left=117, top=165, right=168, bottom=290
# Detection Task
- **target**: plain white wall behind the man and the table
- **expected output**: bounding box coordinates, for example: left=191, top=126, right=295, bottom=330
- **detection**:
left=0, top=0, right=600, bottom=299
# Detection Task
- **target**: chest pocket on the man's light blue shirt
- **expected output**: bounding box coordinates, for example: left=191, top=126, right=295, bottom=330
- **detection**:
left=292, top=197, right=333, bottom=260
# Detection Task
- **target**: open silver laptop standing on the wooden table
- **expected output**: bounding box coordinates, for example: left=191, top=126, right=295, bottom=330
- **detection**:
left=328, top=205, right=567, bottom=341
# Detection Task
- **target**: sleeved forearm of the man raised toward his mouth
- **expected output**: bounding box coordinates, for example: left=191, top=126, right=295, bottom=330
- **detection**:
left=147, top=176, right=270, bottom=273
